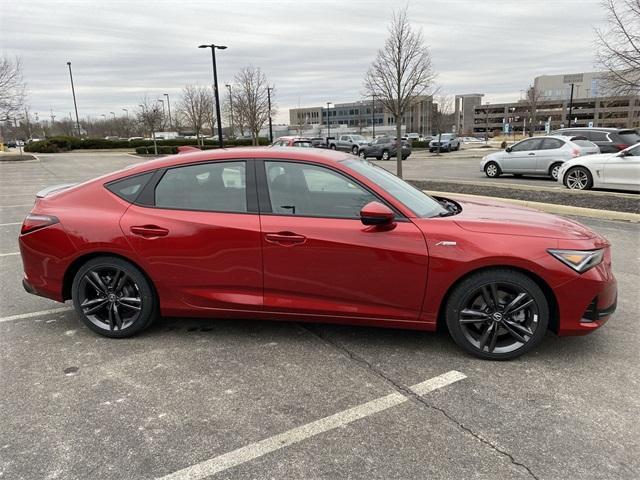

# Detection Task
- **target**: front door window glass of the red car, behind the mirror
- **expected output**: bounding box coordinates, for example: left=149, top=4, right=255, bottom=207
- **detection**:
left=265, top=161, right=377, bottom=218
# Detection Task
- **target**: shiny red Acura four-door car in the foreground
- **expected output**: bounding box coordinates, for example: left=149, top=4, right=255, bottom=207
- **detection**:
left=20, top=148, right=616, bottom=359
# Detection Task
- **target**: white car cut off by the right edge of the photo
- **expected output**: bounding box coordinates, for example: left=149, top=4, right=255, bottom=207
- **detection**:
left=558, top=143, right=640, bottom=191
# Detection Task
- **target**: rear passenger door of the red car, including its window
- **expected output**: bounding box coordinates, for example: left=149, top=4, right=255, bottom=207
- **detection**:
left=120, top=160, right=262, bottom=315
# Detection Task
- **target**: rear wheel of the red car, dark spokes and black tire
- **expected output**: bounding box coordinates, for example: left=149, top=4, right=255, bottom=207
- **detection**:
left=71, top=256, right=158, bottom=338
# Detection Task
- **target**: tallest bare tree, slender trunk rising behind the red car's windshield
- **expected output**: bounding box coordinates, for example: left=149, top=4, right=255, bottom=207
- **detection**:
left=364, top=7, right=435, bottom=177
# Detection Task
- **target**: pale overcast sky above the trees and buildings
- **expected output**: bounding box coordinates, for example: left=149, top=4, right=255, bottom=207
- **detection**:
left=0, top=0, right=603, bottom=122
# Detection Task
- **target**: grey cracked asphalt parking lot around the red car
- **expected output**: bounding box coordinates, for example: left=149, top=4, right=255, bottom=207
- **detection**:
left=0, top=153, right=640, bottom=479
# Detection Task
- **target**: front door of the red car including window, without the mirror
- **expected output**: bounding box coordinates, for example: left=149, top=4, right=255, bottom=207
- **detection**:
left=256, top=160, right=428, bottom=321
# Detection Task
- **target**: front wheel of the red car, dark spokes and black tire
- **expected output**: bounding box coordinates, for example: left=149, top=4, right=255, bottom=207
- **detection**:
left=446, top=268, right=549, bottom=360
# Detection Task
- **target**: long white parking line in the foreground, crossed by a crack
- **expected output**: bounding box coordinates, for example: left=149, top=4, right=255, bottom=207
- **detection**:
left=159, top=370, right=467, bottom=480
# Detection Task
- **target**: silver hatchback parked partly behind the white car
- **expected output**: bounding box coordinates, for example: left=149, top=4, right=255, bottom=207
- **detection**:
left=480, top=135, right=600, bottom=180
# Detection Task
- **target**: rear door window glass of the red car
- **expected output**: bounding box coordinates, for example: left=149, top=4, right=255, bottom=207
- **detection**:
left=155, top=162, right=247, bottom=213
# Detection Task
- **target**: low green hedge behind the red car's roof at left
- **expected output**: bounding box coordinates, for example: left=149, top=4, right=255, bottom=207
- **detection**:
left=25, top=136, right=270, bottom=153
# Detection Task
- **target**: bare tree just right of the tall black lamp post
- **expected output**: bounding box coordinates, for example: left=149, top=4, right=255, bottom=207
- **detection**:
left=233, top=66, right=275, bottom=145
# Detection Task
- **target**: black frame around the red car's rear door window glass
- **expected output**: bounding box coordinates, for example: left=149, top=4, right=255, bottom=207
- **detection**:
left=134, top=158, right=258, bottom=215
